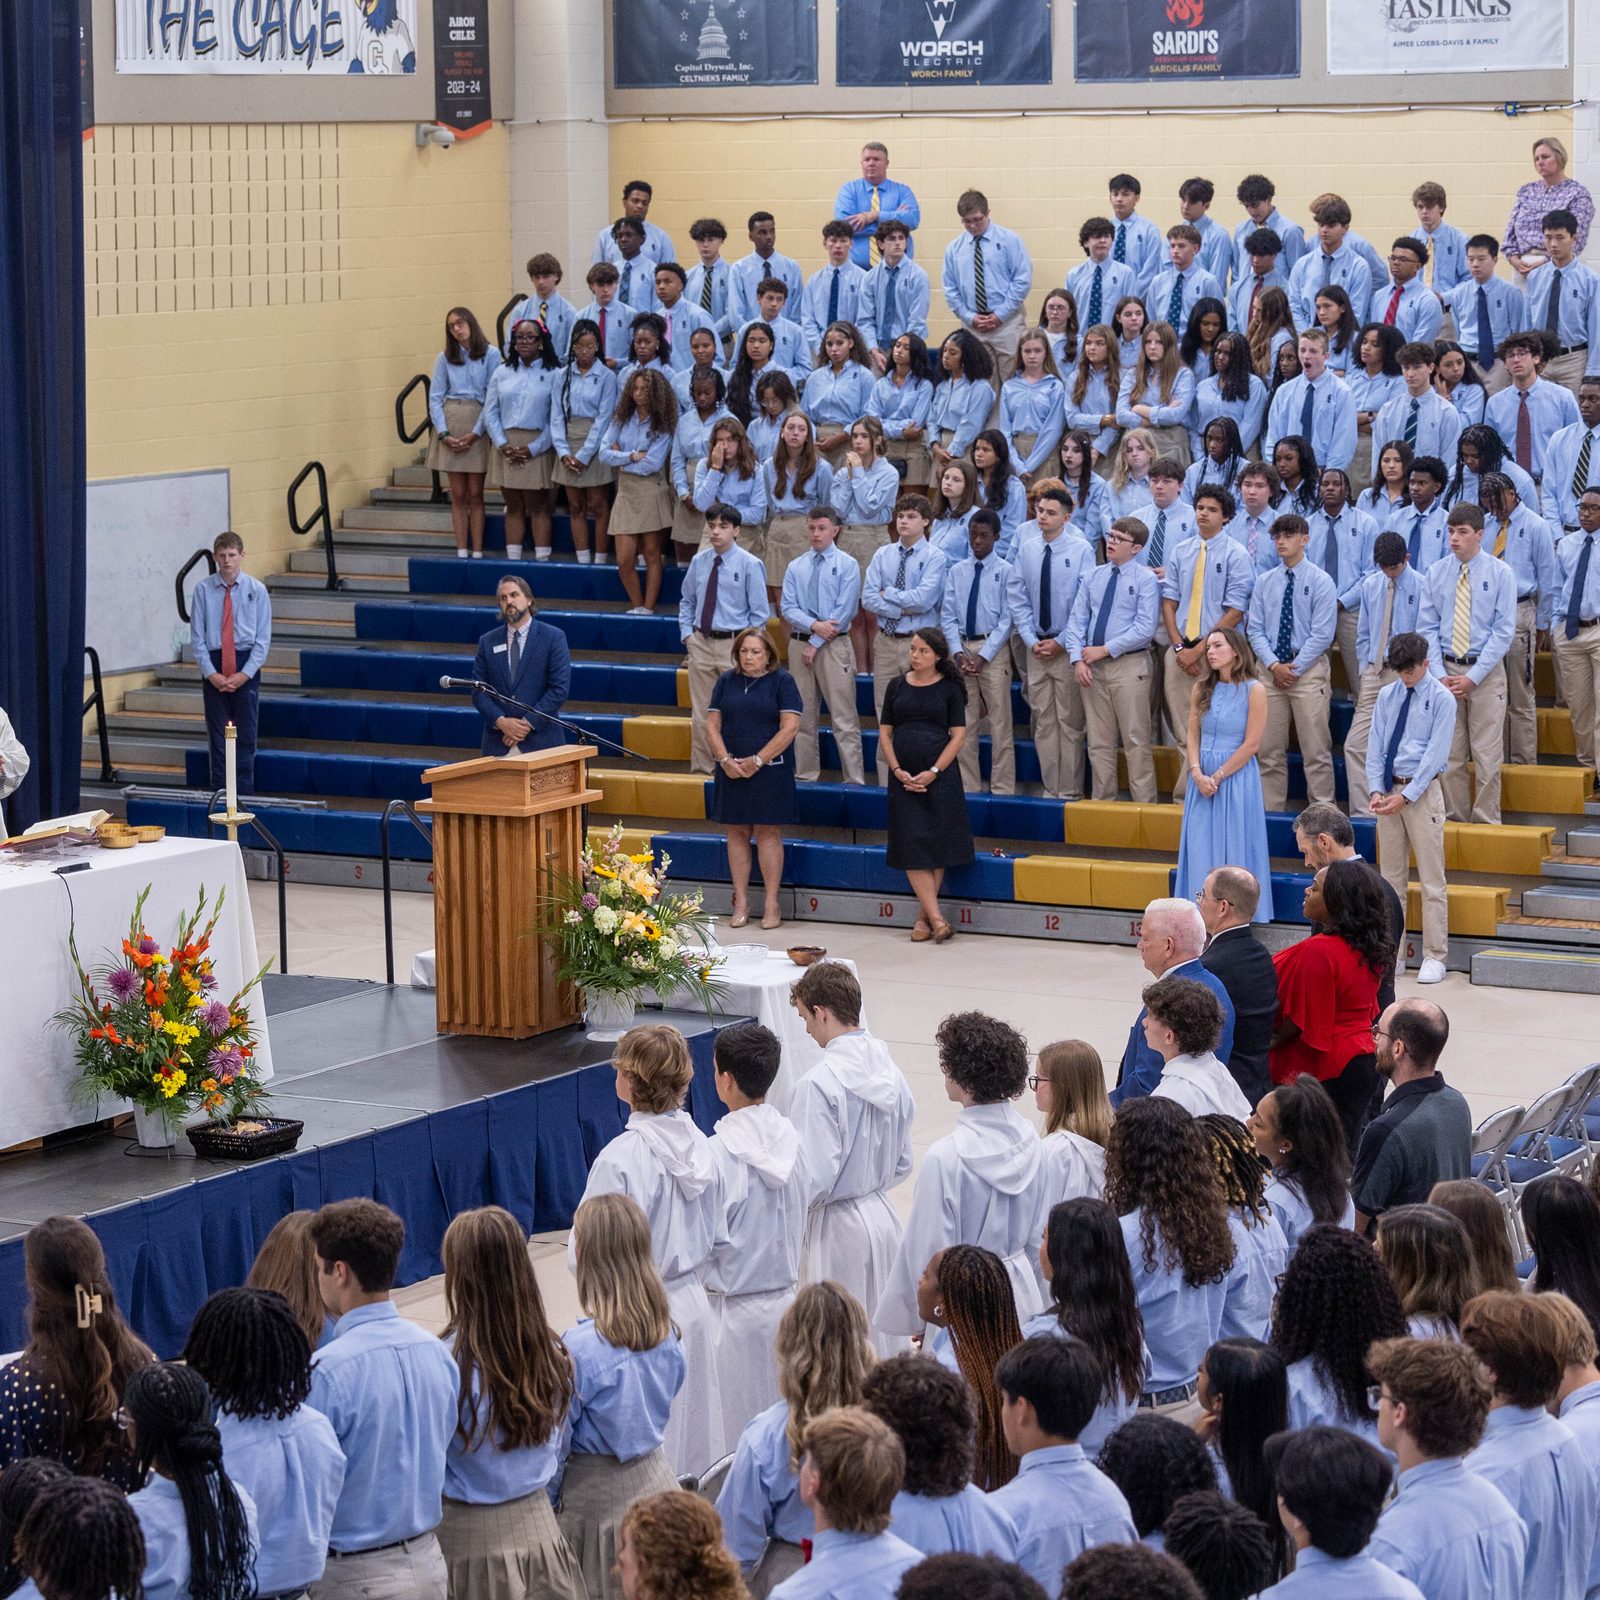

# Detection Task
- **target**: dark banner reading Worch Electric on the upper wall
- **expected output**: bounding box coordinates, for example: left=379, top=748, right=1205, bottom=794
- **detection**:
left=837, top=0, right=1051, bottom=88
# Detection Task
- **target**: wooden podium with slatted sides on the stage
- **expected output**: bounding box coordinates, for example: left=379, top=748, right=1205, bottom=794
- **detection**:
left=418, top=744, right=602, bottom=1038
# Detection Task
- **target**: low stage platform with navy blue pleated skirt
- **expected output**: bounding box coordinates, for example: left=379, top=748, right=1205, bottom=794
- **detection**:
left=0, top=976, right=738, bottom=1357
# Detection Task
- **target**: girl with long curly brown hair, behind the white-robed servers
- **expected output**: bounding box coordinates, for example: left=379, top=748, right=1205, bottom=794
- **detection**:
left=1106, top=1096, right=1238, bottom=1410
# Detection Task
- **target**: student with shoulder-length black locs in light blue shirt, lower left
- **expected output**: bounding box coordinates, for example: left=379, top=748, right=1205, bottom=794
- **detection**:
left=182, top=1288, right=346, bottom=1595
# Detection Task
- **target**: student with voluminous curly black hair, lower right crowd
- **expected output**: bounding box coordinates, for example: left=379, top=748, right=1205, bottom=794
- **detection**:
left=1270, top=1222, right=1408, bottom=1443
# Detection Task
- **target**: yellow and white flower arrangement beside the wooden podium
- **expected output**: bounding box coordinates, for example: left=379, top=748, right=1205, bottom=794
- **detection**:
left=546, top=827, right=717, bottom=1011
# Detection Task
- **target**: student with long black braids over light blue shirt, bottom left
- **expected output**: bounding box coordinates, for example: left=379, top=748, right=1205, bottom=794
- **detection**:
left=123, top=1362, right=257, bottom=1600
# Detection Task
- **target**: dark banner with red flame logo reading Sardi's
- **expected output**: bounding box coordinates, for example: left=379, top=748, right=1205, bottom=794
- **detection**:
left=1074, top=0, right=1299, bottom=83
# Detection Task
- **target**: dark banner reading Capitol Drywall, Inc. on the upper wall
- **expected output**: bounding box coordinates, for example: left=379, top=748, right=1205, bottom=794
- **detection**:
left=611, top=0, right=816, bottom=90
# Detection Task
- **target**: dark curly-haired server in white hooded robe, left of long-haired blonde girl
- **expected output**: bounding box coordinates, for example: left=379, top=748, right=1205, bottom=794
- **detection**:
left=872, top=1011, right=1046, bottom=1334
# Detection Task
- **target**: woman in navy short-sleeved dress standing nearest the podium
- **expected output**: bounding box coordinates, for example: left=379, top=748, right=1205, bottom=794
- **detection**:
left=706, top=627, right=800, bottom=928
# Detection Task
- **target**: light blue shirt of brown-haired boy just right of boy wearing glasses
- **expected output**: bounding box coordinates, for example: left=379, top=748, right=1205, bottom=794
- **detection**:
left=1467, top=1405, right=1595, bottom=1600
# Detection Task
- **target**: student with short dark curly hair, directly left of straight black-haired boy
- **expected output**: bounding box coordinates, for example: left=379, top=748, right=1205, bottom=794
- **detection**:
left=862, top=1355, right=1016, bottom=1562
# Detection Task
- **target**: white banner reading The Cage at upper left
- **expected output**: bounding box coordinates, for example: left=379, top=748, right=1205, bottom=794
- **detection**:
left=116, top=0, right=419, bottom=77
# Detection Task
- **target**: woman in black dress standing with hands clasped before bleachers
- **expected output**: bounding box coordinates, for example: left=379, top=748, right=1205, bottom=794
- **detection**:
left=878, top=627, right=973, bottom=944
